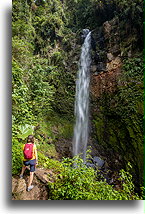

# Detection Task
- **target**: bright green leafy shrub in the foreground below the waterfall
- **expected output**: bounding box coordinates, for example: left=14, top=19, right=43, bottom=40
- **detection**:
left=48, top=157, right=139, bottom=200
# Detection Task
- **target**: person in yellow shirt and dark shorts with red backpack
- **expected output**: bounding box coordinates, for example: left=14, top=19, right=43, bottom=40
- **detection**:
left=20, top=135, right=38, bottom=192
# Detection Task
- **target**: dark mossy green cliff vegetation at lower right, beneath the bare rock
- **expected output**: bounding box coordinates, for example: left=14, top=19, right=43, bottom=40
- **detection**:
left=93, top=55, right=143, bottom=189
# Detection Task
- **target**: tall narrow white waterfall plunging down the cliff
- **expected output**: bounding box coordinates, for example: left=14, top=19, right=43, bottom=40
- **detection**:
left=73, top=29, right=91, bottom=161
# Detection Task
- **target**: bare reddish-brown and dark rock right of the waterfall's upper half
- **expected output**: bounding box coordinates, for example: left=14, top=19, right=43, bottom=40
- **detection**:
left=90, top=19, right=122, bottom=100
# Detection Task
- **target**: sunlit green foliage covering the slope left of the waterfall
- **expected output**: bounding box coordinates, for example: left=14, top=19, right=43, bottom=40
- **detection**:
left=12, top=0, right=75, bottom=174
